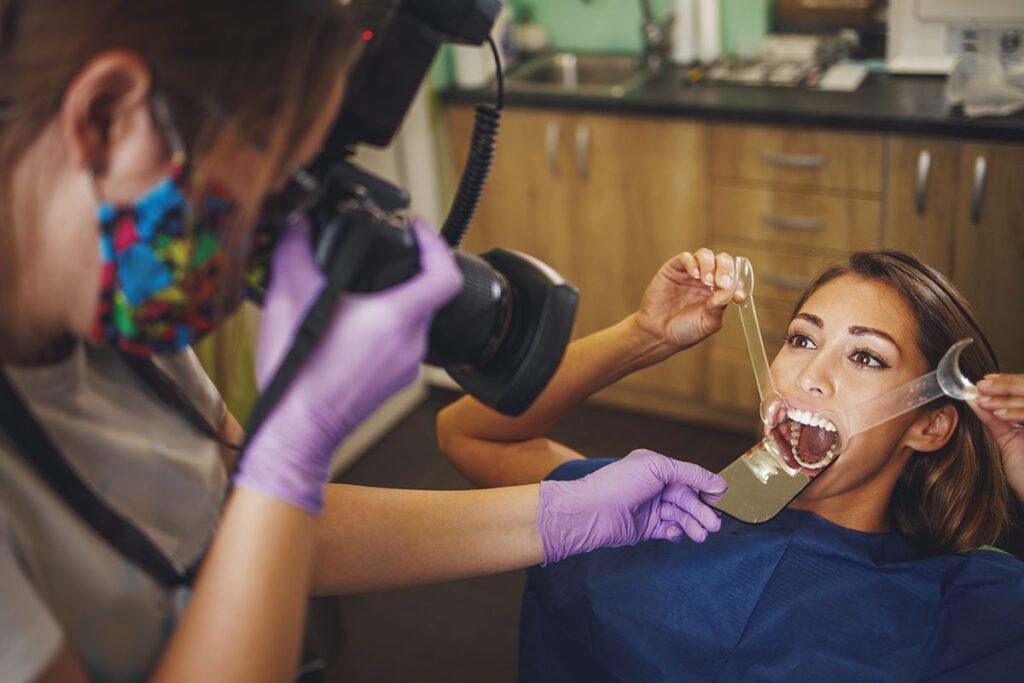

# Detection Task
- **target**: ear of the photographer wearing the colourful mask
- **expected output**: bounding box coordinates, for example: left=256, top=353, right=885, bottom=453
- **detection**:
left=59, top=50, right=159, bottom=179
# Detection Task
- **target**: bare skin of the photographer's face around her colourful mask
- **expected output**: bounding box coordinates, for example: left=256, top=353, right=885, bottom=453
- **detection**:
left=0, top=54, right=343, bottom=362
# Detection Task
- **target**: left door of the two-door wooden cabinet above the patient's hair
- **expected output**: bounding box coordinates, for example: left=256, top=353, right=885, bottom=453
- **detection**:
left=883, top=136, right=961, bottom=275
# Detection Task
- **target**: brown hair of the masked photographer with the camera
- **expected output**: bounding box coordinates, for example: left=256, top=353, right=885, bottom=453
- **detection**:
left=0, top=0, right=360, bottom=339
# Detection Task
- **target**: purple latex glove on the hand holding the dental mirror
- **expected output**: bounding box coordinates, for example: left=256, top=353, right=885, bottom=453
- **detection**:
left=537, top=451, right=727, bottom=565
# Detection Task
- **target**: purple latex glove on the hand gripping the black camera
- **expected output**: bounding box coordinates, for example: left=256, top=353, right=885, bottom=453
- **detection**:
left=234, top=220, right=462, bottom=514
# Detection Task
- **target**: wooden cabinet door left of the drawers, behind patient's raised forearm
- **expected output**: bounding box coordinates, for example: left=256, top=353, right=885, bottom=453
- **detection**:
left=568, top=115, right=708, bottom=405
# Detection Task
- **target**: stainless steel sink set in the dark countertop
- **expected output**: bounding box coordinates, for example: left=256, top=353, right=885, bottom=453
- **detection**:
left=506, top=52, right=653, bottom=97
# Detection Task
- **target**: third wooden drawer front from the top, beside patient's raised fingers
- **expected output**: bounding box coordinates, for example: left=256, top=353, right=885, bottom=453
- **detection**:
left=713, top=241, right=838, bottom=311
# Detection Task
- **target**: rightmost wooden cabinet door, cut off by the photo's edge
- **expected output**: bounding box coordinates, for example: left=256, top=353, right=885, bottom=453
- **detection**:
left=953, top=144, right=1024, bottom=372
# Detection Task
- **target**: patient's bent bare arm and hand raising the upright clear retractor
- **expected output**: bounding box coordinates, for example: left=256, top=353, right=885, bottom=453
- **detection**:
left=437, top=249, right=739, bottom=486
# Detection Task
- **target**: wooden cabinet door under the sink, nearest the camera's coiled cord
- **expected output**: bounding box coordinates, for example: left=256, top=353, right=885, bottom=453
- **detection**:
left=449, top=106, right=581, bottom=278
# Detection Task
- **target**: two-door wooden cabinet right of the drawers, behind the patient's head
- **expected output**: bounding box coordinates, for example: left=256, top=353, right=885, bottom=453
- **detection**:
left=885, top=136, right=1024, bottom=372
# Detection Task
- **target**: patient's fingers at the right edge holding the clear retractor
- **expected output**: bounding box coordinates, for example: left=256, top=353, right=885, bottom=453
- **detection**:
left=969, top=375, right=1024, bottom=501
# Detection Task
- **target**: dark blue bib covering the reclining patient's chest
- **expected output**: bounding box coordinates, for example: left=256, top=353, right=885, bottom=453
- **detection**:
left=519, top=460, right=1024, bottom=683
